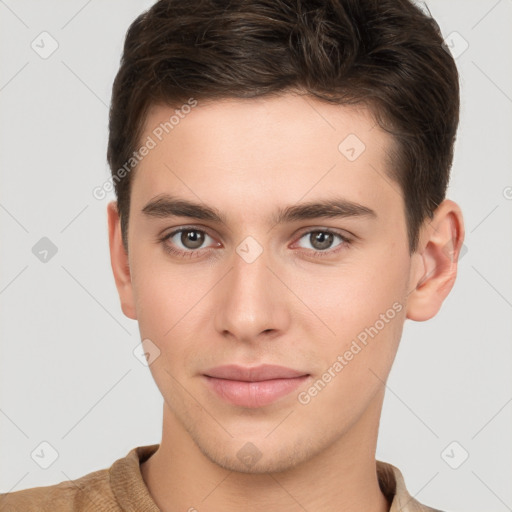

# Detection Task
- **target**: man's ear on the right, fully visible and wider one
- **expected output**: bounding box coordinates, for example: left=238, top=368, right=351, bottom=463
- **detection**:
left=406, top=199, right=464, bottom=322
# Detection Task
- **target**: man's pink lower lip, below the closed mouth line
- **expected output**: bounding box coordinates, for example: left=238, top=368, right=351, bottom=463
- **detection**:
left=204, top=375, right=309, bottom=409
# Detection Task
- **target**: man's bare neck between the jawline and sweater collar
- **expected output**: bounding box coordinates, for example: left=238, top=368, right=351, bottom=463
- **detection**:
left=141, top=396, right=389, bottom=512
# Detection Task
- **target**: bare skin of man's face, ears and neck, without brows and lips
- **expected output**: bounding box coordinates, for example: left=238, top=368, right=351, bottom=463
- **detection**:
left=108, top=93, right=464, bottom=512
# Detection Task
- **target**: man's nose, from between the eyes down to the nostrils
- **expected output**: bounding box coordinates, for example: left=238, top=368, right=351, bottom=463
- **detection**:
left=216, top=236, right=286, bottom=340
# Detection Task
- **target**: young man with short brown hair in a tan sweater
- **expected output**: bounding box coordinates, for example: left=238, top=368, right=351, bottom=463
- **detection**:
left=0, top=0, right=464, bottom=512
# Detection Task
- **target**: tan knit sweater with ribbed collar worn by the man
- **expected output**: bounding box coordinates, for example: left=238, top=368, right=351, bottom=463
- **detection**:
left=0, top=444, right=440, bottom=512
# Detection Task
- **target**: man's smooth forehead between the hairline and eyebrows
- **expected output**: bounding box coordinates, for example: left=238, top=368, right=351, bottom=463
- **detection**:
left=132, top=94, right=401, bottom=222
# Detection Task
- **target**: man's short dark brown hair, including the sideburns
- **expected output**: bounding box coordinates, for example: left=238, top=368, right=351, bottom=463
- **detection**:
left=107, top=0, right=459, bottom=253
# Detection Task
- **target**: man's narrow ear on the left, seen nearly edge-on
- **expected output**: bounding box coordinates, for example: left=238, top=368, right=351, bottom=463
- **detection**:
left=107, top=201, right=137, bottom=320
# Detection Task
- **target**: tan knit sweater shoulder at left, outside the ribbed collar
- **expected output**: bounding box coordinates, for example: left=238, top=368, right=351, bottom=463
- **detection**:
left=0, top=469, right=119, bottom=512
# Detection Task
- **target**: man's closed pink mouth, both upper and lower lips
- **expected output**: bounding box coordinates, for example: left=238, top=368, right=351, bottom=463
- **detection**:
left=203, top=365, right=310, bottom=409
